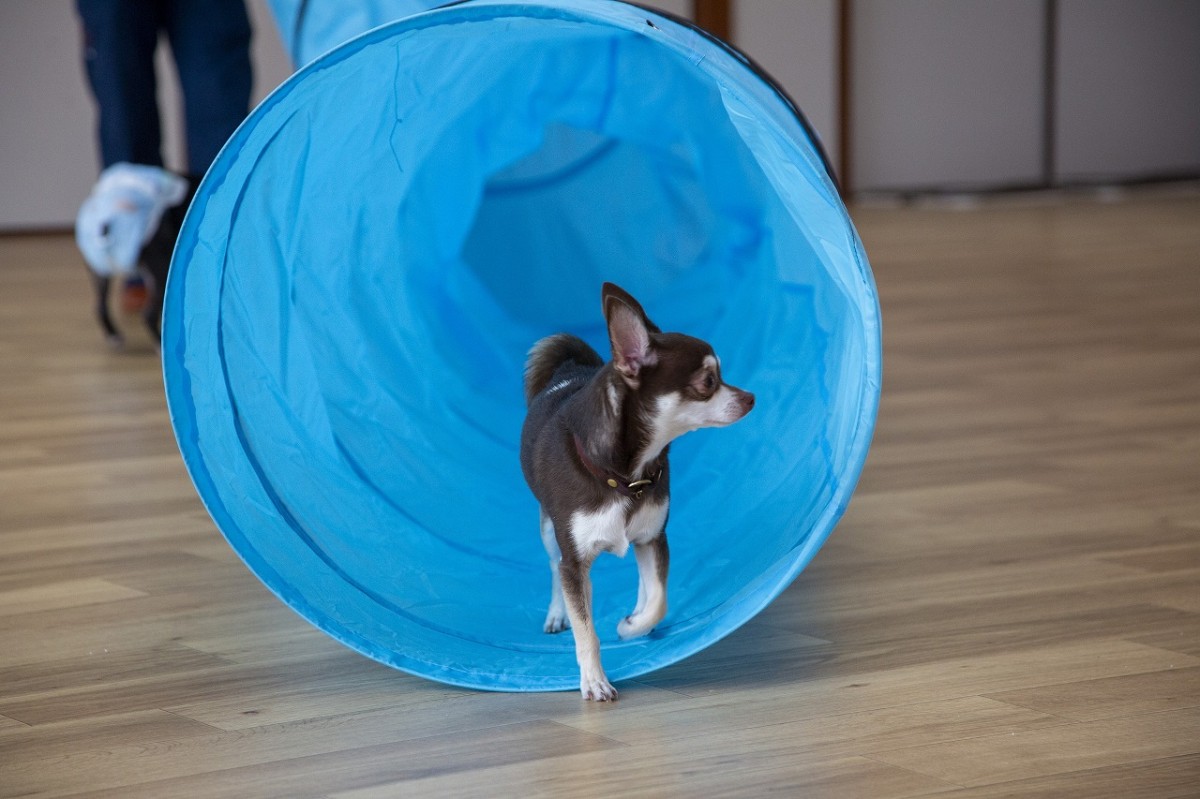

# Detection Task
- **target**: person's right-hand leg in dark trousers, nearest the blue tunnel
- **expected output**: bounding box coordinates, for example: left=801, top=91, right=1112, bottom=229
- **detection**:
left=166, top=0, right=252, bottom=176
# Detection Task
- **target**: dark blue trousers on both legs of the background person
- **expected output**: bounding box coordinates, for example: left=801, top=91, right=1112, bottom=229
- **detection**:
left=76, top=0, right=252, bottom=178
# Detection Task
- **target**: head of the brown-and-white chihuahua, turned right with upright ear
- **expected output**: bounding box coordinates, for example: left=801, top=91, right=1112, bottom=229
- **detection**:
left=601, top=283, right=755, bottom=450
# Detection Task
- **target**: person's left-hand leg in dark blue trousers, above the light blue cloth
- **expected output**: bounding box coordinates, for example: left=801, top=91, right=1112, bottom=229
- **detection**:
left=76, top=0, right=162, bottom=167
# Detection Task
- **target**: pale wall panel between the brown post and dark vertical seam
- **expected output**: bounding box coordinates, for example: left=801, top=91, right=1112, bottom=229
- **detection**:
left=851, top=0, right=1045, bottom=191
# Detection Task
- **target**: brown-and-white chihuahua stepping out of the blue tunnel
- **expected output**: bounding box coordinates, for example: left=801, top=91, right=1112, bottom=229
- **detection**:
left=521, top=283, right=755, bottom=702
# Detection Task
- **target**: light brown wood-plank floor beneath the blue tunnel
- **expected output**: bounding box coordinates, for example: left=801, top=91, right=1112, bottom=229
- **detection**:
left=0, top=193, right=1200, bottom=799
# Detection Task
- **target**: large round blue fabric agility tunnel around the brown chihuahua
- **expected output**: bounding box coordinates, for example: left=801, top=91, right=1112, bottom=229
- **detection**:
left=162, top=0, right=881, bottom=691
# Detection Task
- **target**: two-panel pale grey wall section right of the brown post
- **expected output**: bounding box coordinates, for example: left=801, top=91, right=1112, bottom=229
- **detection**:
left=854, top=0, right=1200, bottom=192
